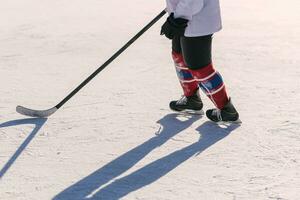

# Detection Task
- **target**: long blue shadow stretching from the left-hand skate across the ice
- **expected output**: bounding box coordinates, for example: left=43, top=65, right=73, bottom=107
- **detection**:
left=53, top=113, right=201, bottom=200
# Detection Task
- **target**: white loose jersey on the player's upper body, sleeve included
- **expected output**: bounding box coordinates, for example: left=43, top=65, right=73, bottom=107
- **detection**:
left=166, top=0, right=222, bottom=37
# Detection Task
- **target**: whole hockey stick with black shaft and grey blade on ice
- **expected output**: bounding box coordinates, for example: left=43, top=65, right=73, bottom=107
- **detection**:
left=16, top=10, right=166, bottom=118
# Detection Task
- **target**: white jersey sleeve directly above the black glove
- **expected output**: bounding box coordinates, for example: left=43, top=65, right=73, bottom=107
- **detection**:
left=174, top=0, right=204, bottom=20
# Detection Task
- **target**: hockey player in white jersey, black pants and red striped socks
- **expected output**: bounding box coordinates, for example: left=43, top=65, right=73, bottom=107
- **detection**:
left=161, top=0, right=239, bottom=122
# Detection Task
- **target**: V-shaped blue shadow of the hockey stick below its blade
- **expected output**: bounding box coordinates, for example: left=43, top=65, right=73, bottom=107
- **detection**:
left=0, top=118, right=47, bottom=180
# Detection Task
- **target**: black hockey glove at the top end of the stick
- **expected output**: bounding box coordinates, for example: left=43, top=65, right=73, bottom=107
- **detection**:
left=160, top=13, right=189, bottom=39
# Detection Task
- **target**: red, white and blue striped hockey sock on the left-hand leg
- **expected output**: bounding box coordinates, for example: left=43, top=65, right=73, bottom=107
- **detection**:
left=172, top=52, right=199, bottom=97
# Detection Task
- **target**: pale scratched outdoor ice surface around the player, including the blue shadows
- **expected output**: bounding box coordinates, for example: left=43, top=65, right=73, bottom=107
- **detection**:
left=0, top=0, right=300, bottom=200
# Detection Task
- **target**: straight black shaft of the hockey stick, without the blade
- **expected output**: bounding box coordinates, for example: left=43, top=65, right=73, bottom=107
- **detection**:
left=55, top=10, right=166, bottom=109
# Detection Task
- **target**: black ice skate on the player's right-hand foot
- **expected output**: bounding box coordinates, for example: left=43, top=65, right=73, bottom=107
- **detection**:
left=206, top=99, right=242, bottom=123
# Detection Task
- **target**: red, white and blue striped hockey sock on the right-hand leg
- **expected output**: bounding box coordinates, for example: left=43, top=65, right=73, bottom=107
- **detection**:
left=191, top=64, right=229, bottom=109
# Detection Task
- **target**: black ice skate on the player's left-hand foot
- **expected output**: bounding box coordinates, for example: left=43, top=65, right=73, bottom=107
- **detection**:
left=169, top=90, right=204, bottom=115
